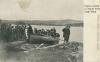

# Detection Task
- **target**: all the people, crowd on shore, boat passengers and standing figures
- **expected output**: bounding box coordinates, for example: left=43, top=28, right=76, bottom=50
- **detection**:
left=0, top=24, right=70, bottom=43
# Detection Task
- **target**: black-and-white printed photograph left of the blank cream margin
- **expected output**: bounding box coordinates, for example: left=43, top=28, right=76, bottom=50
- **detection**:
left=0, top=0, right=84, bottom=62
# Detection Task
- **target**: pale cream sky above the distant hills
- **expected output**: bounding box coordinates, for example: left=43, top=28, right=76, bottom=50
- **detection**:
left=0, top=0, right=83, bottom=20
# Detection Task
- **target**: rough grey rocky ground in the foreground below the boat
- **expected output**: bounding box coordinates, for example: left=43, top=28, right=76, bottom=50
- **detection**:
left=0, top=42, right=83, bottom=62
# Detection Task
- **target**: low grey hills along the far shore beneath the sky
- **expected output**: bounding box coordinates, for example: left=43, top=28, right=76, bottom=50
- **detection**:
left=0, top=19, right=83, bottom=27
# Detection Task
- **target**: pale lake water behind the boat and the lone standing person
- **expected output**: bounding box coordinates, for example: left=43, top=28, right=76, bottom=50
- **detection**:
left=32, top=25, right=83, bottom=42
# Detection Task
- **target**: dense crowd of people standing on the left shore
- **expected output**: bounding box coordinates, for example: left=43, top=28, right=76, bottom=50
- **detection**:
left=0, top=24, right=26, bottom=42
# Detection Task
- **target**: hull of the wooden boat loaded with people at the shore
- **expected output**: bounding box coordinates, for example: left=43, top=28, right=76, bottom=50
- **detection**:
left=29, top=35, right=59, bottom=45
